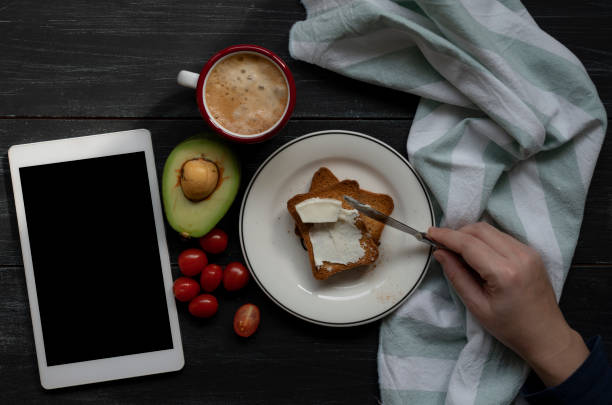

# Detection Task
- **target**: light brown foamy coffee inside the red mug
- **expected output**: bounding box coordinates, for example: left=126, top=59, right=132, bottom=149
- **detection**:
left=204, top=53, right=289, bottom=135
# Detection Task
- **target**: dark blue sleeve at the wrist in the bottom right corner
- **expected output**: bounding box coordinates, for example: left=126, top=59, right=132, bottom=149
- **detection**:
left=522, top=336, right=612, bottom=405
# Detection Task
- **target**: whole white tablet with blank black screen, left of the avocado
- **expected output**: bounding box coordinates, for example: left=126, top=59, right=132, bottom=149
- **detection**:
left=9, top=129, right=184, bottom=389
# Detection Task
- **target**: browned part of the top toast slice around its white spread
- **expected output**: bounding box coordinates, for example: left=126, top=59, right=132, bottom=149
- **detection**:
left=287, top=180, right=378, bottom=280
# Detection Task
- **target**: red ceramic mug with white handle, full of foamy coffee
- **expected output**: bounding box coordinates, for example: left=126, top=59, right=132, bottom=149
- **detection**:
left=177, top=45, right=295, bottom=143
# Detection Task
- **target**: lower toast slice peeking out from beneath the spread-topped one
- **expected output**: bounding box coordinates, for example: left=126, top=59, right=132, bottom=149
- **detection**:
left=309, top=167, right=394, bottom=244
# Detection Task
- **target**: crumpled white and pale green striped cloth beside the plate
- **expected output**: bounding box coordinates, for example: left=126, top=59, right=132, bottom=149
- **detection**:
left=289, top=0, right=607, bottom=405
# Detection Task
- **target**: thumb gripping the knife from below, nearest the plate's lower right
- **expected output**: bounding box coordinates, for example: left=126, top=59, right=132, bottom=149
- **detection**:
left=434, top=249, right=487, bottom=314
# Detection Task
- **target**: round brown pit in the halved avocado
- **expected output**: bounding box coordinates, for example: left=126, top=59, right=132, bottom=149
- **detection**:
left=180, top=158, right=219, bottom=202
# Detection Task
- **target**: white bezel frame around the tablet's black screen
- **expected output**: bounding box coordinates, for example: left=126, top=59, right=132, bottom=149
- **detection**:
left=8, top=129, right=185, bottom=389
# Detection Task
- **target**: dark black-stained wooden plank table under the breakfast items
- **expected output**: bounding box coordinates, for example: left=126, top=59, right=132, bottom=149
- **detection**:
left=0, top=0, right=612, bottom=404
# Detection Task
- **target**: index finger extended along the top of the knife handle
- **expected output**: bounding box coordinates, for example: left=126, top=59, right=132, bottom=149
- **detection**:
left=428, top=228, right=505, bottom=282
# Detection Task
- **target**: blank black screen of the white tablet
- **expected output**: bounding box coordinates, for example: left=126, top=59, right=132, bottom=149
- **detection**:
left=19, top=152, right=173, bottom=366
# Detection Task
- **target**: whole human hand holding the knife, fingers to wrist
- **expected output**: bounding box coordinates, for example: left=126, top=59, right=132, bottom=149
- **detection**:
left=428, top=222, right=589, bottom=386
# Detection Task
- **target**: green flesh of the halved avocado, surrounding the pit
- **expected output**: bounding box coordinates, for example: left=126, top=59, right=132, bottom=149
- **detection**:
left=162, top=135, right=240, bottom=238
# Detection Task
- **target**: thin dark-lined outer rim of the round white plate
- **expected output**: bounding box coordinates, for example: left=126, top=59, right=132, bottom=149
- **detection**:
left=238, top=129, right=436, bottom=327
